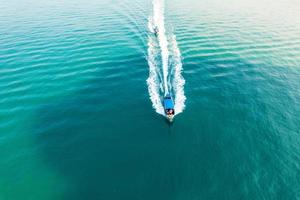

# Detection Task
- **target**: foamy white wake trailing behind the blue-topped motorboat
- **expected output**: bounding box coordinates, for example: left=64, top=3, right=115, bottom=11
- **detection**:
left=147, top=0, right=186, bottom=115
